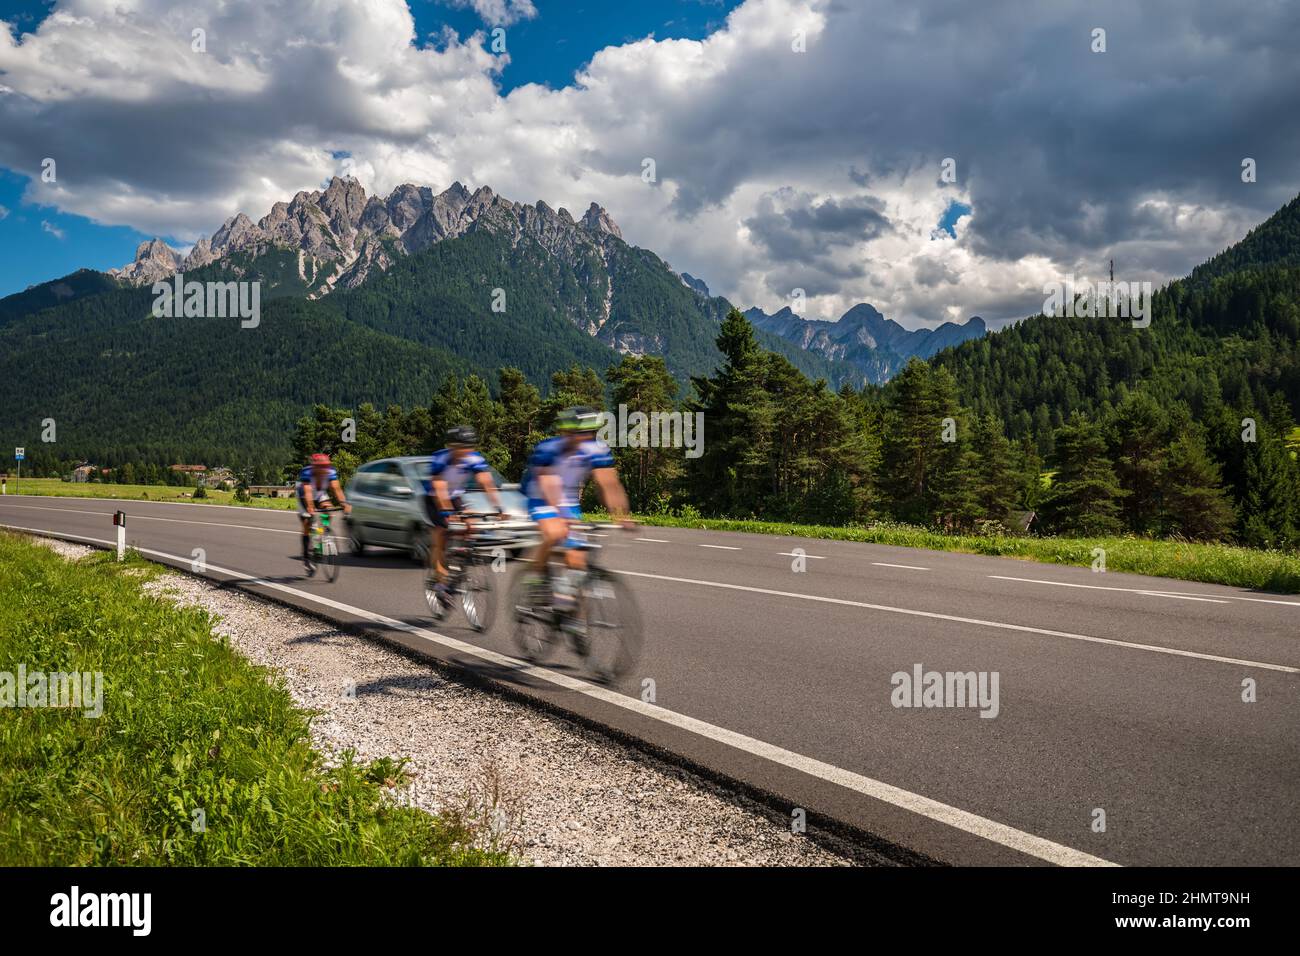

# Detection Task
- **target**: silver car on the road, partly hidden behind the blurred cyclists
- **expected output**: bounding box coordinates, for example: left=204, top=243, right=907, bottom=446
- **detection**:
left=345, top=455, right=537, bottom=564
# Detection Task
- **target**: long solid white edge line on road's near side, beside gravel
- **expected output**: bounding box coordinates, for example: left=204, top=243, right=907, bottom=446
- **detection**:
left=0, top=525, right=1119, bottom=866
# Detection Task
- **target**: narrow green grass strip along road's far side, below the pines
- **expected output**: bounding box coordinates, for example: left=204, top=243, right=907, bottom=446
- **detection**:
left=616, top=515, right=1300, bottom=594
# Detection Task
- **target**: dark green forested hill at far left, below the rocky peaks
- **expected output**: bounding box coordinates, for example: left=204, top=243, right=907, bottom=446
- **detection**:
left=0, top=289, right=471, bottom=470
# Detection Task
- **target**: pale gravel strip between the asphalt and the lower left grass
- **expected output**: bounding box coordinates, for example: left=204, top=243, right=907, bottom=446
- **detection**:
left=36, top=538, right=887, bottom=866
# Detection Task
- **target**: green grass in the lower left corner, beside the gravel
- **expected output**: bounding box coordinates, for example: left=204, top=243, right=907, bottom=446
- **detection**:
left=0, top=532, right=510, bottom=866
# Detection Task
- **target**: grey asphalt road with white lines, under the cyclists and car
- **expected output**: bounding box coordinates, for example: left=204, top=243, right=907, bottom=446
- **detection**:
left=0, top=496, right=1300, bottom=865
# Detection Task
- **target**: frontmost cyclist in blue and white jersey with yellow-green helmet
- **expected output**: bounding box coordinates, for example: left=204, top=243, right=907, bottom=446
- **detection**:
left=521, top=406, right=636, bottom=600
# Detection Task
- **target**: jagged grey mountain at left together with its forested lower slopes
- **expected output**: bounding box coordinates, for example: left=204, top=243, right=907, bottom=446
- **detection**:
left=0, top=178, right=909, bottom=462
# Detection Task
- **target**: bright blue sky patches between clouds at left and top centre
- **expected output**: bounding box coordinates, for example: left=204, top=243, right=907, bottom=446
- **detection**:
left=0, top=0, right=737, bottom=297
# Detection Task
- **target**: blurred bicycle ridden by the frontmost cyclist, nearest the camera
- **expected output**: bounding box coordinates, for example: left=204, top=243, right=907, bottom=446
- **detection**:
left=510, top=524, right=642, bottom=683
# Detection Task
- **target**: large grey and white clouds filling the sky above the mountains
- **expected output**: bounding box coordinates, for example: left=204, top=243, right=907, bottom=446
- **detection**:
left=0, top=0, right=1300, bottom=325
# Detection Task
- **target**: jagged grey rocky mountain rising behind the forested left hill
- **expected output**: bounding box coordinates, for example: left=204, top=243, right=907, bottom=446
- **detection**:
left=98, top=177, right=861, bottom=385
